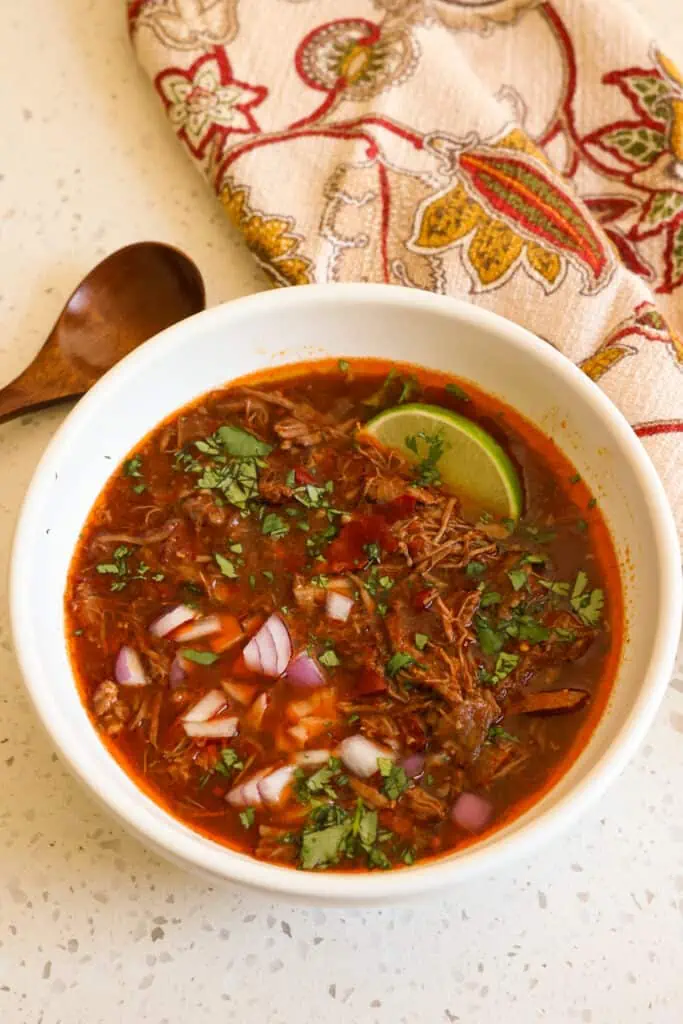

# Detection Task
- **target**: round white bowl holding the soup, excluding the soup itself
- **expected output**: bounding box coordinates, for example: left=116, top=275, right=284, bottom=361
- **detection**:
left=11, top=285, right=681, bottom=904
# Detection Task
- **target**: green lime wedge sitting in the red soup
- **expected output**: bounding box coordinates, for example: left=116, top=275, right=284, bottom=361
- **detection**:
left=364, top=403, right=522, bottom=520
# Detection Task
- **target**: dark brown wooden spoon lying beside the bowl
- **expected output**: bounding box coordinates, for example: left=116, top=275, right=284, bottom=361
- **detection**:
left=0, top=242, right=206, bottom=423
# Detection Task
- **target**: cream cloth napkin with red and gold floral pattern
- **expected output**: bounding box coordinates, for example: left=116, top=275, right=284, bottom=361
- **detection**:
left=128, top=0, right=683, bottom=527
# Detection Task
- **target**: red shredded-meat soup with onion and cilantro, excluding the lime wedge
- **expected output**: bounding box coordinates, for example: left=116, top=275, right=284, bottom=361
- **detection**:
left=66, top=359, right=623, bottom=870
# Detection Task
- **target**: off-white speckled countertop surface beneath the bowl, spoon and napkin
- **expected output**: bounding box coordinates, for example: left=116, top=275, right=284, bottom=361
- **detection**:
left=0, top=0, right=683, bottom=1024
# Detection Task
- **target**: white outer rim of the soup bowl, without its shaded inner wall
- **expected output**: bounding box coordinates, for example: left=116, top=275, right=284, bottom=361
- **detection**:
left=9, top=284, right=683, bottom=905
